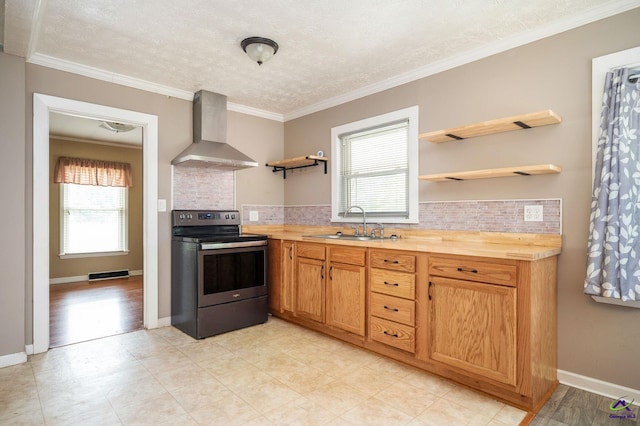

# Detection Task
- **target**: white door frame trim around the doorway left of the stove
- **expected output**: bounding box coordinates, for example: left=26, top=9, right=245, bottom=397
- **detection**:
left=32, top=93, right=158, bottom=353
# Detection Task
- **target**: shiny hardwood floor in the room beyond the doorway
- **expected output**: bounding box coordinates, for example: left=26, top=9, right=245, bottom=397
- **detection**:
left=49, top=276, right=143, bottom=348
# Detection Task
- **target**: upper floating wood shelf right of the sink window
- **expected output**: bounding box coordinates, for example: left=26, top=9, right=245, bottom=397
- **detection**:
left=419, top=109, right=562, bottom=143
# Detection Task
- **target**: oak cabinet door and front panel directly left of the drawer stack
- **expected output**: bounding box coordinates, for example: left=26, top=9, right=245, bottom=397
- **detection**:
left=326, top=246, right=367, bottom=336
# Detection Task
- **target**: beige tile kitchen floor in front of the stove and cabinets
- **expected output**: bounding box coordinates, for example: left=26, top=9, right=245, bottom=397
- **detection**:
left=0, top=317, right=526, bottom=426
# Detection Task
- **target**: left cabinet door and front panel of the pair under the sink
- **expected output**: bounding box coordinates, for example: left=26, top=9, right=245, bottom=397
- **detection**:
left=294, top=243, right=326, bottom=323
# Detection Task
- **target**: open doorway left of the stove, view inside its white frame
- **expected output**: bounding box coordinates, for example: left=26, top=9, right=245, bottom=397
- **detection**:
left=49, top=113, right=143, bottom=348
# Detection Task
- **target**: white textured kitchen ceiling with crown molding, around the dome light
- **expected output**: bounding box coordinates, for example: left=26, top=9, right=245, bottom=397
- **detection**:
left=4, top=0, right=640, bottom=120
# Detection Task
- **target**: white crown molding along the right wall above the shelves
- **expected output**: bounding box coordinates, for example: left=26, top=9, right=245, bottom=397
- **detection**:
left=284, top=0, right=638, bottom=122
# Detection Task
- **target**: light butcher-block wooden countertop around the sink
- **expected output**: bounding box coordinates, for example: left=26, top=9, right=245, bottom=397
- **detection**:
left=242, top=225, right=562, bottom=261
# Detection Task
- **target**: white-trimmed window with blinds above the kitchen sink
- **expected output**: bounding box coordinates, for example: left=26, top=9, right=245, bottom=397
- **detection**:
left=331, top=106, right=418, bottom=223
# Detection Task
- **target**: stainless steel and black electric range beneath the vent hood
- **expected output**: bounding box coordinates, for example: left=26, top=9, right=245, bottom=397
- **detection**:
left=171, top=210, right=268, bottom=339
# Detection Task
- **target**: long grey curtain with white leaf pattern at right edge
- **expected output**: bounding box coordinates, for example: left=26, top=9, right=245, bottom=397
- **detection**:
left=584, top=68, right=640, bottom=301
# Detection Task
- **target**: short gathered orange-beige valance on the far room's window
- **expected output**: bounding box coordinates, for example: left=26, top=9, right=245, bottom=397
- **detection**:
left=53, top=157, right=133, bottom=186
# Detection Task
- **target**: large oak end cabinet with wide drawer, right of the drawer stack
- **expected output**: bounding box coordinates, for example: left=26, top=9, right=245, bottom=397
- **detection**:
left=428, top=255, right=557, bottom=409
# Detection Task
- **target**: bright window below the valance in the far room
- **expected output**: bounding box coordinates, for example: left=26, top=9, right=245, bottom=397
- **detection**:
left=60, top=183, right=128, bottom=257
